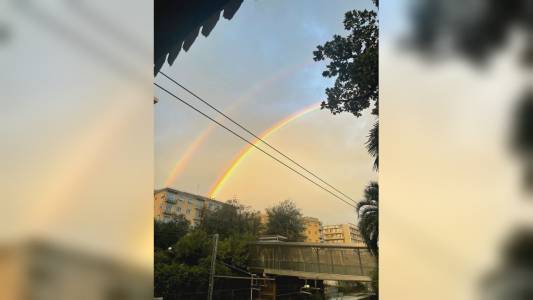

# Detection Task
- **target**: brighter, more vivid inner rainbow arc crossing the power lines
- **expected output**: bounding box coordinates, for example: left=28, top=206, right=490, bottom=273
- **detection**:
left=209, top=102, right=320, bottom=198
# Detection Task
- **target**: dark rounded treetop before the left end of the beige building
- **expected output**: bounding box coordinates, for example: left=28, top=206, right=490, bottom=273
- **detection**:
left=154, top=215, right=189, bottom=249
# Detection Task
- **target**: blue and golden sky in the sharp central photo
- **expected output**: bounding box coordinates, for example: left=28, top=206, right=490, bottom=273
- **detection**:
left=154, top=0, right=377, bottom=224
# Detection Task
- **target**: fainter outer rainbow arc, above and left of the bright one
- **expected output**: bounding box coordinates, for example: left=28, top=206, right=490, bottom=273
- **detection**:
left=165, top=61, right=314, bottom=187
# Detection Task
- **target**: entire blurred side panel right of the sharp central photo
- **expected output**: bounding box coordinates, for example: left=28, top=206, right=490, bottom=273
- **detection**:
left=380, top=0, right=533, bottom=300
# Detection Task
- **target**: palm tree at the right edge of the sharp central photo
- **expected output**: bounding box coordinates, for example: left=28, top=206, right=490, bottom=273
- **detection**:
left=356, top=181, right=379, bottom=256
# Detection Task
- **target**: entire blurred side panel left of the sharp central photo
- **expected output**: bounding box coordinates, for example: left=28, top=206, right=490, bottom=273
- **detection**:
left=0, top=0, right=153, bottom=300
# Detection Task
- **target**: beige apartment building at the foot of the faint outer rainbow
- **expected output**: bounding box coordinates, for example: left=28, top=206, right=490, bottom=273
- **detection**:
left=154, top=188, right=224, bottom=225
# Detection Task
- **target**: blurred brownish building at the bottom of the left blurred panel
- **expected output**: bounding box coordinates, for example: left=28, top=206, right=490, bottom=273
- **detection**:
left=0, top=240, right=153, bottom=300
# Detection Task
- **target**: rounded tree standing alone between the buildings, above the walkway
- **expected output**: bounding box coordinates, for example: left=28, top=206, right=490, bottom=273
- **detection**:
left=266, top=200, right=305, bottom=242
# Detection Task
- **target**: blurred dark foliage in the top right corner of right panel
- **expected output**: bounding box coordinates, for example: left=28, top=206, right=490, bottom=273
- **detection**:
left=411, top=0, right=533, bottom=64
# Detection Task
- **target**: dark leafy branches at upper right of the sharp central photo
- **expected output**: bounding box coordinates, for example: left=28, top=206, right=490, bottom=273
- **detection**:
left=313, top=0, right=379, bottom=169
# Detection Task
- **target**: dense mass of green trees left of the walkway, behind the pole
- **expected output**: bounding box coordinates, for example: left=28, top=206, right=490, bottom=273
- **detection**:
left=154, top=201, right=260, bottom=299
